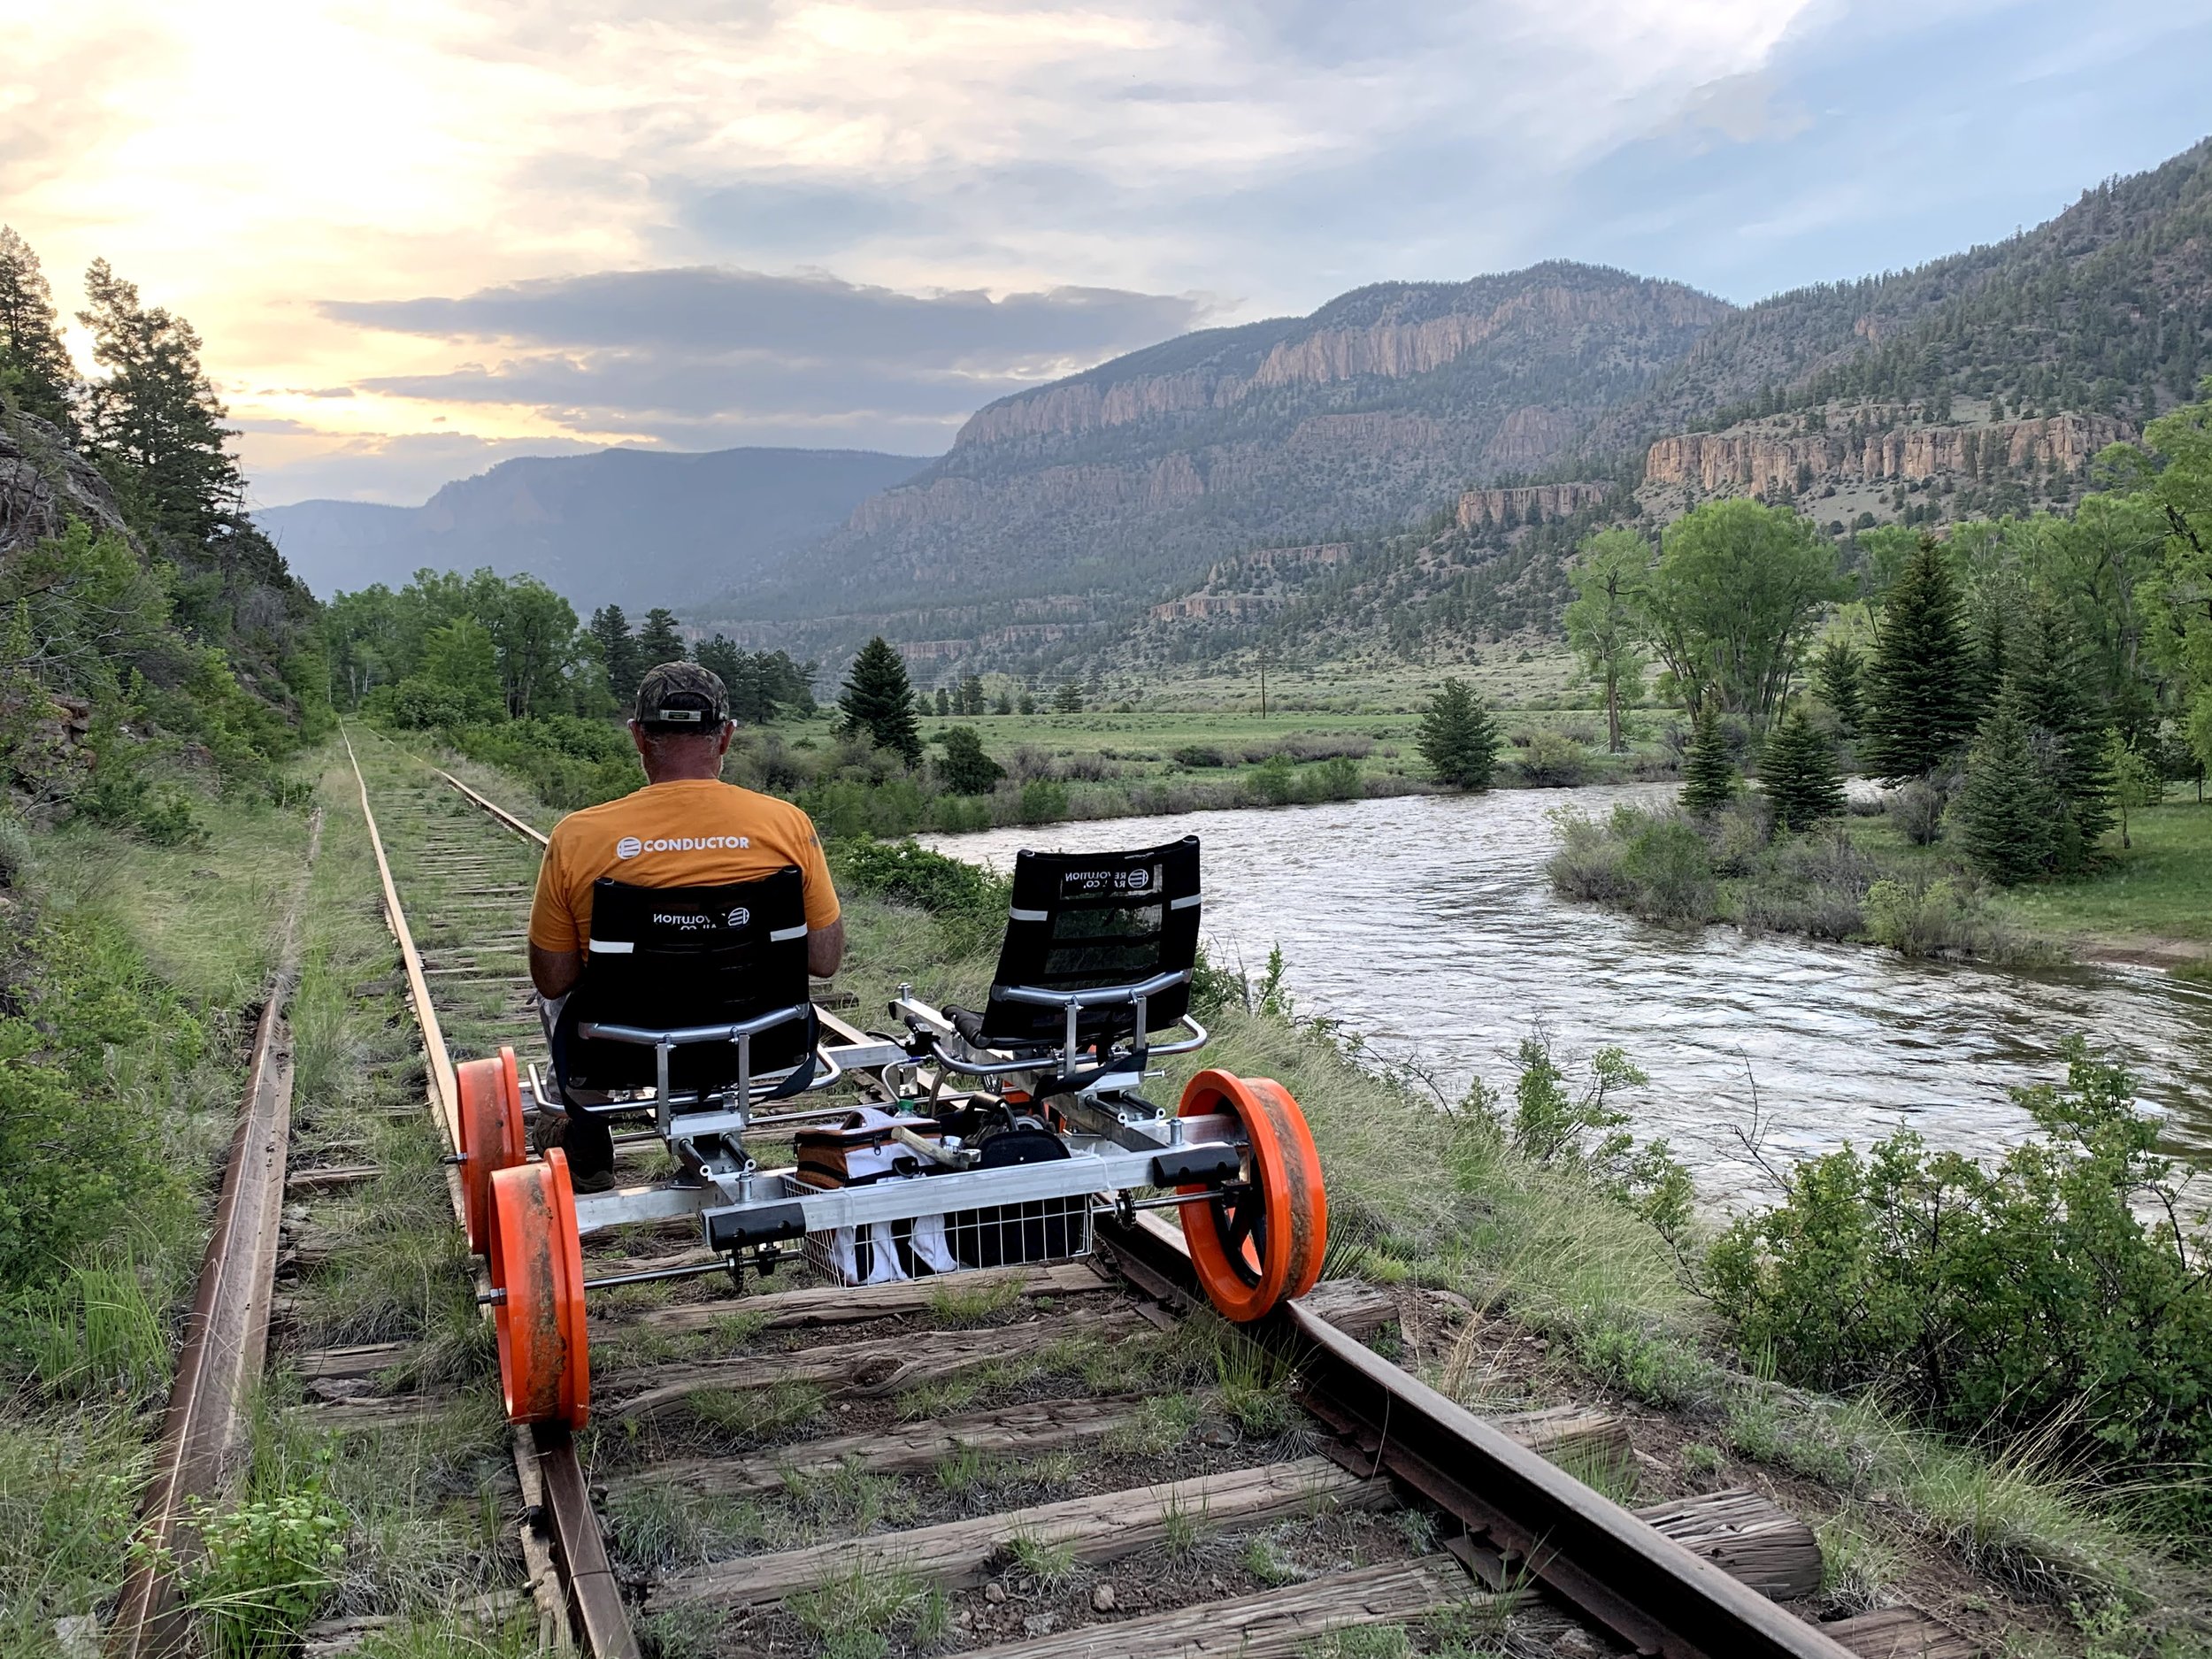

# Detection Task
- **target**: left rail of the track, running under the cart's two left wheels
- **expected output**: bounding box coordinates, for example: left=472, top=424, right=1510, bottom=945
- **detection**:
left=341, top=733, right=640, bottom=1659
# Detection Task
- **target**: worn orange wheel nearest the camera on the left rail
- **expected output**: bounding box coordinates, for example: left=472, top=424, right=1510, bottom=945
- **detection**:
left=489, top=1146, right=591, bottom=1429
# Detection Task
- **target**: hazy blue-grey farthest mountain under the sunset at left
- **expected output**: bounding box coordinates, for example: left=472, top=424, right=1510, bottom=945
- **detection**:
left=255, top=449, right=929, bottom=613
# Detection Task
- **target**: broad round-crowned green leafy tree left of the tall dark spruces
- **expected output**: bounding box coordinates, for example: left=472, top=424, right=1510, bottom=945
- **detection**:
left=1637, top=500, right=1843, bottom=730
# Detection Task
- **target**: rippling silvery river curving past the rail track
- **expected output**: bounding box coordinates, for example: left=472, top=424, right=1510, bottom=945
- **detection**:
left=932, top=786, right=2212, bottom=1208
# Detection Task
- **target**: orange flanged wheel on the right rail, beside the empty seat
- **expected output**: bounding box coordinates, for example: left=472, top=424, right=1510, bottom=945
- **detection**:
left=1181, top=1071, right=1330, bottom=1323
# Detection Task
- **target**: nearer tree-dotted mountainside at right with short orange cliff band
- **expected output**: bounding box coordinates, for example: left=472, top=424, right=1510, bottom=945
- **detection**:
left=1115, top=142, right=2212, bottom=672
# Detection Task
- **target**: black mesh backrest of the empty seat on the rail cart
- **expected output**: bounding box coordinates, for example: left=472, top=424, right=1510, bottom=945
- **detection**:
left=982, top=836, right=1199, bottom=1047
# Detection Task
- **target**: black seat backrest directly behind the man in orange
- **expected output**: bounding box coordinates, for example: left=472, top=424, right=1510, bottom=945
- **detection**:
left=553, top=867, right=817, bottom=1093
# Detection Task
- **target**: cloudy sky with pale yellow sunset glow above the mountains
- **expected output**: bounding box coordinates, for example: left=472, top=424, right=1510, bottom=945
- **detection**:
left=0, top=0, right=2212, bottom=504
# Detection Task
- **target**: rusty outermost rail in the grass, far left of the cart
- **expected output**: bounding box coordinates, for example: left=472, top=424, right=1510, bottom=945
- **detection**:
left=106, top=810, right=323, bottom=1659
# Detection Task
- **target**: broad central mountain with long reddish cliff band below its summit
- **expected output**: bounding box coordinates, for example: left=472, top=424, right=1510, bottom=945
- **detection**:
left=695, top=264, right=1734, bottom=655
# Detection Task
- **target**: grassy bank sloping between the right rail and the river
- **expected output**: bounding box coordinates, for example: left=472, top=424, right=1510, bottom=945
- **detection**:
left=839, top=845, right=2206, bottom=1659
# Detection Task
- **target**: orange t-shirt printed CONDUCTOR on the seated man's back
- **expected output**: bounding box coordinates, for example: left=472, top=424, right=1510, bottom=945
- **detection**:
left=531, top=779, right=839, bottom=951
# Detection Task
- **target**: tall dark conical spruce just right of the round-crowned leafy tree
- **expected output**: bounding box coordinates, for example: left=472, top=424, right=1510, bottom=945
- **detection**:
left=1858, top=535, right=1973, bottom=783
